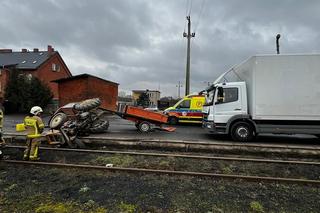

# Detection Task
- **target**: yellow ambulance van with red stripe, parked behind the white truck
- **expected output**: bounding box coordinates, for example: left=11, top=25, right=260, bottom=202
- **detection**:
left=164, top=95, right=205, bottom=124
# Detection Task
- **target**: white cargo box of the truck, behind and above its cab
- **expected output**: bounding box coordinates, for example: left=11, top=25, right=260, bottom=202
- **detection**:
left=221, top=54, right=320, bottom=120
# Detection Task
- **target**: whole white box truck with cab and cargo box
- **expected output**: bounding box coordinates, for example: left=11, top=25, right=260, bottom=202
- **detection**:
left=203, top=54, right=320, bottom=141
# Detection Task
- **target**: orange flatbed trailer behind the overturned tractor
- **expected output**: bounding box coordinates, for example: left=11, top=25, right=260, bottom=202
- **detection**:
left=116, top=106, right=175, bottom=132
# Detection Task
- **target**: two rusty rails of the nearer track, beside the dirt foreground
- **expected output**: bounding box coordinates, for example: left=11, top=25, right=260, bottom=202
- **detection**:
left=2, top=146, right=320, bottom=185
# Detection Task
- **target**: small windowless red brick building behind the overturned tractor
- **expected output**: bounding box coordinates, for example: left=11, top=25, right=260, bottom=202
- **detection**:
left=53, top=74, right=119, bottom=111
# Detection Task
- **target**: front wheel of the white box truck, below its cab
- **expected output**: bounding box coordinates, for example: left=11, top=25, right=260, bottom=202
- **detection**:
left=231, top=122, right=254, bottom=142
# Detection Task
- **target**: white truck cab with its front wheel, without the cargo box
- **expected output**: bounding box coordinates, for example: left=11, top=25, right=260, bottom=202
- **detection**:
left=202, top=82, right=255, bottom=141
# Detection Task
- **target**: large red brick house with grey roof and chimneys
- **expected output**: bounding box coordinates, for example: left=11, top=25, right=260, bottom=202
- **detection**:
left=0, top=45, right=72, bottom=103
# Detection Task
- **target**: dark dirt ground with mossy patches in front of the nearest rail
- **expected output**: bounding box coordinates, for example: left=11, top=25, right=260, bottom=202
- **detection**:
left=0, top=163, right=320, bottom=213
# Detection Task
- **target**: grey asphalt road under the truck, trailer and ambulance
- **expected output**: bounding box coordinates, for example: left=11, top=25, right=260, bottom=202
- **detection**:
left=3, top=115, right=320, bottom=145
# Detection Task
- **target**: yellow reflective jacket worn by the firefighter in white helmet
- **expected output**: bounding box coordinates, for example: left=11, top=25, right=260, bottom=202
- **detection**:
left=24, top=115, right=44, bottom=138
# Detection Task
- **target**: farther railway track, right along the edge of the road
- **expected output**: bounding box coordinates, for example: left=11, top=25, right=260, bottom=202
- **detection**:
left=6, top=133, right=320, bottom=157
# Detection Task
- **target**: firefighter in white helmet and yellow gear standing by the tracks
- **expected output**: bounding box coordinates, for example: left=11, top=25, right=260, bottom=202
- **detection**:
left=23, top=106, right=44, bottom=160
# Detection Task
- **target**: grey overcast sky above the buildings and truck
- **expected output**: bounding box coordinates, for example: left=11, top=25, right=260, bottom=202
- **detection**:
left=0, top=0, right=320, bottom=97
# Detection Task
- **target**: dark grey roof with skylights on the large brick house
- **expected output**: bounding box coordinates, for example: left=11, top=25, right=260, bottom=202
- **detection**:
left=0, top=51, right=51, bottom=69
